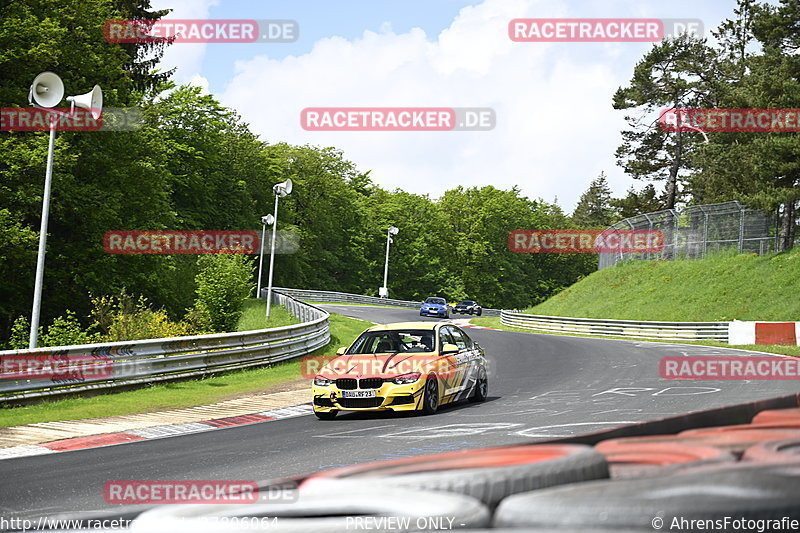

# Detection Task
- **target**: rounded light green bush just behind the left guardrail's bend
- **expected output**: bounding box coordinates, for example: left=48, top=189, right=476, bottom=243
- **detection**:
left=186, top=254, right=254, bottom=332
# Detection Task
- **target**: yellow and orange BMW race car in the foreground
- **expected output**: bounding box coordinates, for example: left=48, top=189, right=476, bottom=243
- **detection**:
left=312, top=322, right=488, bottom=420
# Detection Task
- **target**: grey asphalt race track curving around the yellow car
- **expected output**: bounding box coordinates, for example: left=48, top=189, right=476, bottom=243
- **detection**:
left=0, top=305, right=797, bottom=518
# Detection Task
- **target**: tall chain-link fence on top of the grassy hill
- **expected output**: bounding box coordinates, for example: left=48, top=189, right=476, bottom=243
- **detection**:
left=598, top=201, right=778, bottom=270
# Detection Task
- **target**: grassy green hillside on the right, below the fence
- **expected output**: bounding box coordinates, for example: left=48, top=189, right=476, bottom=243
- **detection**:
left=527, top=249, right=800, bottom=321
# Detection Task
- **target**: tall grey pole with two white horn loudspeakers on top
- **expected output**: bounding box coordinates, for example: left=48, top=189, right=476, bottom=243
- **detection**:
left=28, top=72, right=103, bottom=349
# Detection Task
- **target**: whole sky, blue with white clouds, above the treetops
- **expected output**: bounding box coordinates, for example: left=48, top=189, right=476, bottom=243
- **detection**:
left=148, top=0, right=735, bottom=211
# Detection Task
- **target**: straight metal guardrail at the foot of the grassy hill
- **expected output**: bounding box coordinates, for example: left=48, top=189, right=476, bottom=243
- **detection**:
left=500, top=311, right=728, bottom=342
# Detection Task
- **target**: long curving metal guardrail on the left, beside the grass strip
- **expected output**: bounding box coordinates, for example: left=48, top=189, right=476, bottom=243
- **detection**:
left=0, top=293, right=330, bottom=401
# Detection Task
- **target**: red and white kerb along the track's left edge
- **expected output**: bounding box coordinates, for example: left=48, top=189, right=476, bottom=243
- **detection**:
left=0, top=403, right=314, bottom=460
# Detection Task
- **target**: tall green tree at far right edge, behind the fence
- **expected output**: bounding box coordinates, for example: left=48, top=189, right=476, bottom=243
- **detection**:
left=691, top=0, right=800, bottom=250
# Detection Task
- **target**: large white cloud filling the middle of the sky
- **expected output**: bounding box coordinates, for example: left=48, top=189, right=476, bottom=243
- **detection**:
left=220, top=0, right=644, bottom=210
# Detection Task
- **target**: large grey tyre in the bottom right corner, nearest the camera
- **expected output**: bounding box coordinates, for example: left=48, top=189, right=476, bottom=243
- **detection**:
left=493, top=463, right=800, bottom=531
